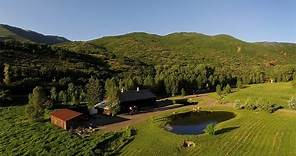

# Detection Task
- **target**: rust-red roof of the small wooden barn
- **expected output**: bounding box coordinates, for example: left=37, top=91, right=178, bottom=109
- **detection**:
left=51, top=109, right=82, bottom=121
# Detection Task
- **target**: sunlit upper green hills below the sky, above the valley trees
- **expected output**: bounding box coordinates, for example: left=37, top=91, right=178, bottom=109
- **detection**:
left=89, top=33, right=296, bottom=67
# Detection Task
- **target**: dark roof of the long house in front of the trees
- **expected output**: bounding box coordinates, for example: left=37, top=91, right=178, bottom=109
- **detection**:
left=119, top=89, right=156, bottom=102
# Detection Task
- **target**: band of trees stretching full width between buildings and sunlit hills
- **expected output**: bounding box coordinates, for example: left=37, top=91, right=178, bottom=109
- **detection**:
left=0, top=41, right=296, bottom=108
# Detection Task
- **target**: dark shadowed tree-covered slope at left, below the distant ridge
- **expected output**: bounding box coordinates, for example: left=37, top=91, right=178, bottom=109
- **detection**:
left=0, top=41, right=111, bottom=100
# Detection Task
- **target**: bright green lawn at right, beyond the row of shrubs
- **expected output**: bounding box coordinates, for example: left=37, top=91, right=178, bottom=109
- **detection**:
left=225, top=82, right=296, bottom=108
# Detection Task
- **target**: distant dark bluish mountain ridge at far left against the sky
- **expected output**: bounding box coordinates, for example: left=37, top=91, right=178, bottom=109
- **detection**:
left=0, top=24, right=69, bottom=44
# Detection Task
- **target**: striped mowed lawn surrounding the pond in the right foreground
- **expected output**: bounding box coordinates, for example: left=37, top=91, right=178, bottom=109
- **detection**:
left=121, top=106, right=296, bottom=156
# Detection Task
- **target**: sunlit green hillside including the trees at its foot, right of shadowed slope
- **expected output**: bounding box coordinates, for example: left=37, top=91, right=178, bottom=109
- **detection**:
left=57, top=32, right=296, bottom=95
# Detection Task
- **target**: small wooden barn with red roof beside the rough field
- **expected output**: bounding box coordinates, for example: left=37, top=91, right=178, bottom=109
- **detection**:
left=50, top=109, right=83, bottom=130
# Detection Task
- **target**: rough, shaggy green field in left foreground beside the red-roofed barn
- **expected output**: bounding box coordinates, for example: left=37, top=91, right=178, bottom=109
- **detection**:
left=0, top=106, right=130, bottom=156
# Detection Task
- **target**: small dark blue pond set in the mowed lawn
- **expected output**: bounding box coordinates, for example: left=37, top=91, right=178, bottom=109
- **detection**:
left=165, top=111, right=235, bottom=134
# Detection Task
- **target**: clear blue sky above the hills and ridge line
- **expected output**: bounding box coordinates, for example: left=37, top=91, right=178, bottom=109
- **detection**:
left=0, top=0, right=296, bottom=43
